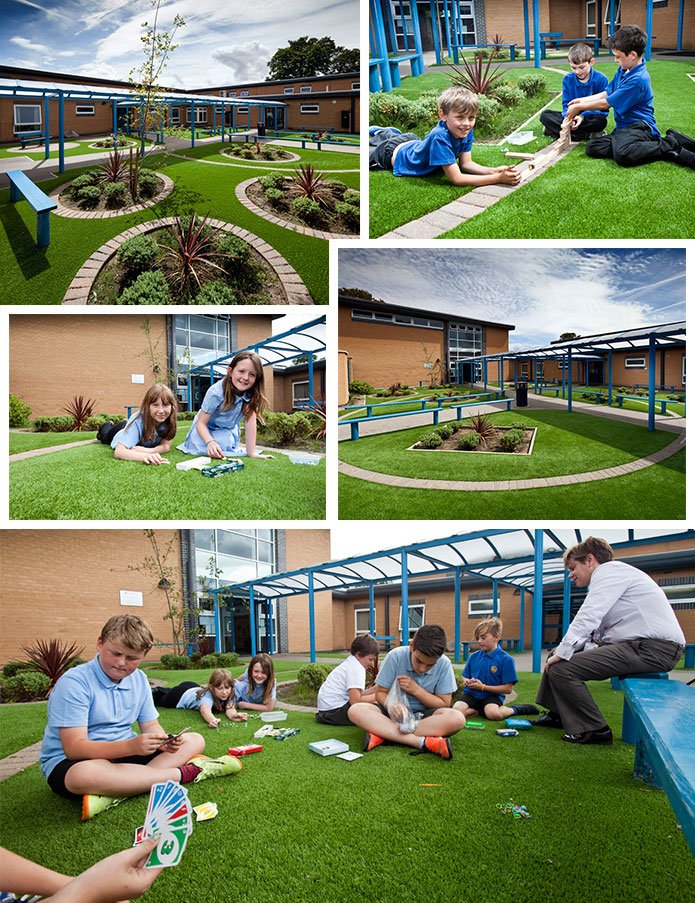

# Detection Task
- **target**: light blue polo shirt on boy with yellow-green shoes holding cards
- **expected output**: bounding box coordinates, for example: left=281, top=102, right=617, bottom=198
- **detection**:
left=40, top=655, right=157, bottom=777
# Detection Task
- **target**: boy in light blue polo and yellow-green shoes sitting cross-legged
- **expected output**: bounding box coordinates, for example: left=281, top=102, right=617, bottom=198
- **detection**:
left=41, top=615, right=241, bottom=819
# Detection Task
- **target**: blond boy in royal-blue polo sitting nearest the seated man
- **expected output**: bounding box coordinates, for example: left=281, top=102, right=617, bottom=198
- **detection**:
left=454, top=618, right=538, bottom=721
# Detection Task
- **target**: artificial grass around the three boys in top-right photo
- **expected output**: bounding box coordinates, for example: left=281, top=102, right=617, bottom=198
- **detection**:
left=370, top=59, right=695, bottom=239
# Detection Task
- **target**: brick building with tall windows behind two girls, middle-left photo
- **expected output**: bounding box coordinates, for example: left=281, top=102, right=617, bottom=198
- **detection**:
left=9, top=313, right=325, bottom=417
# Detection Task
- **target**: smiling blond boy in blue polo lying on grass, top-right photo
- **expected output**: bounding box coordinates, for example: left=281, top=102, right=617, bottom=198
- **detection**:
left=369, top=86, right=521, bottom=186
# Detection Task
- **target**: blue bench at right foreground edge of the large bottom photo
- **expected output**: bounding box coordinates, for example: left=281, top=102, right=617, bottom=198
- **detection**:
left=623, top=677, right=695, bottom=855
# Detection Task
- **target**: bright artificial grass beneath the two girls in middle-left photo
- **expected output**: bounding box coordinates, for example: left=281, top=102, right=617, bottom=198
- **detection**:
left=10, top=423, right=325, bottom=520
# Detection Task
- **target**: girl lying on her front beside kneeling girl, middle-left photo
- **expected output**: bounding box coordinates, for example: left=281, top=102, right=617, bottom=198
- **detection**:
left=97, top=383, right=178, bottom=464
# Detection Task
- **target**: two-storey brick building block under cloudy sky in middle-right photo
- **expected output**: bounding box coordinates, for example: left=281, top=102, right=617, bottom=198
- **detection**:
left=338, top=295, right=514, bottom=404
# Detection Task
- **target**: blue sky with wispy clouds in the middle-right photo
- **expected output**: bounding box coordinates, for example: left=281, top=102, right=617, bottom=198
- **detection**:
left=338, top=247, right=685, bottom=350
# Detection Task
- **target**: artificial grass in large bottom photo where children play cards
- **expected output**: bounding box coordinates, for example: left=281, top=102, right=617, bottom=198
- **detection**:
left=2, top=674, right=695, bottom=903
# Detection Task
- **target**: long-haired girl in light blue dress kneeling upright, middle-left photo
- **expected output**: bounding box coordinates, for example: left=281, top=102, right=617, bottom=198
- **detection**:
left=177, top=351, right=273, bottom=458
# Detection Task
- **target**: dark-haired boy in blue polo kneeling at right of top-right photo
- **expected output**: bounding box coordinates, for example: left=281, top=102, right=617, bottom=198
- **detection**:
left=567, top=25, right=695, bottom=169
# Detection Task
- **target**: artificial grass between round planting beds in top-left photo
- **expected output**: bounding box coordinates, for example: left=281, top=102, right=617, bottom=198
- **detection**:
left=0, top=145, right=359, bottom=304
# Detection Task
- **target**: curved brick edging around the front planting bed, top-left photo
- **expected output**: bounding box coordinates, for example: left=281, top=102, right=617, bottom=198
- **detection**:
left=62, top=216, right=314, bottom=306
